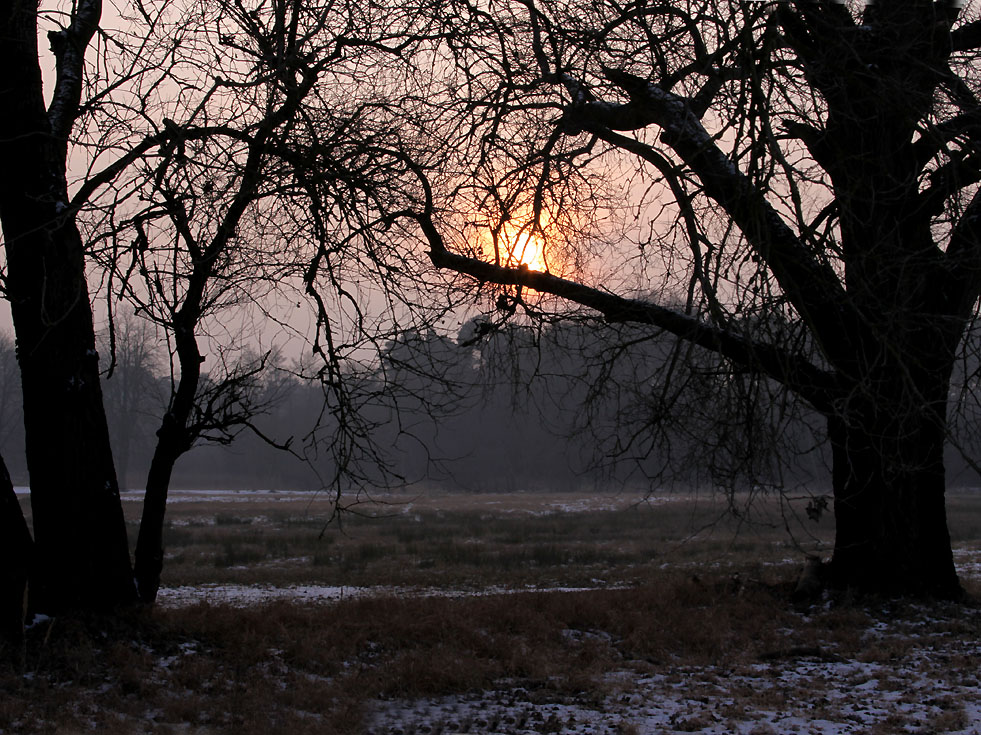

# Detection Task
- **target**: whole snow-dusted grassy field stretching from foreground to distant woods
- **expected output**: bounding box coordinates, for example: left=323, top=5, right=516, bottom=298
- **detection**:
left=0, top=492, right=981, bottom=735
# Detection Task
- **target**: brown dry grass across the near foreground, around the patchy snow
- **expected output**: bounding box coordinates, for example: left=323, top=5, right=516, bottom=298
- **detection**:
left=0, top=572, right=981, bottom=735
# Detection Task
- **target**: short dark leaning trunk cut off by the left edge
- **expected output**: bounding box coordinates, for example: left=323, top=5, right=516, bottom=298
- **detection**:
left=0, top=458, right=33, bottom=668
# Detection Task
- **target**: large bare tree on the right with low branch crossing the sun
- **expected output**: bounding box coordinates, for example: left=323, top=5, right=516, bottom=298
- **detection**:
left=417, top=0, right=981, bottom=597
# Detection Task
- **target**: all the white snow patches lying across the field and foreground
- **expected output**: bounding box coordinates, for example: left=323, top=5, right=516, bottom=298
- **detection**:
left=17, top=488, right=981, bottom=735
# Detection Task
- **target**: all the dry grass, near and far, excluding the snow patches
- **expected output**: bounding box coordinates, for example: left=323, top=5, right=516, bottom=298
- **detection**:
left=7, top=488, right=981, bottom=735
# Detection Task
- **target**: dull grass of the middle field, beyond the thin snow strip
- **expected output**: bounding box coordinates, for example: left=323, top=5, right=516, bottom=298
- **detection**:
left=103, top=493, right=830, bottom=589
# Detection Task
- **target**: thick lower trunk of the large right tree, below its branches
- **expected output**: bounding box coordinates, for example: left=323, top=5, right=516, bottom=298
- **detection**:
left=829, top=386, right=962, bottom=599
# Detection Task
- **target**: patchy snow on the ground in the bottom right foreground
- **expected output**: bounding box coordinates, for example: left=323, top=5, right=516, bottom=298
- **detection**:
left=367, top=612, right=981, bottom=735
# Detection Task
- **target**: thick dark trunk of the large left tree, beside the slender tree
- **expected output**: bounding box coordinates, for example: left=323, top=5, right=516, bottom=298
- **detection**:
left=0, top=0, right=135, bottom=613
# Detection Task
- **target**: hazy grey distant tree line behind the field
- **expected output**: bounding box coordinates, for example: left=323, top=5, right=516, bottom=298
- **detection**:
left=0, top=317, right=844, bottom=492
